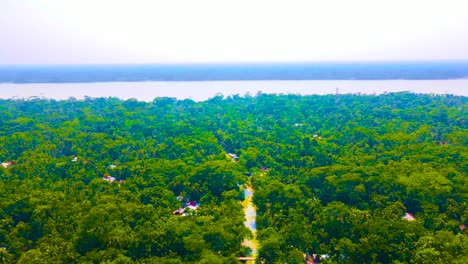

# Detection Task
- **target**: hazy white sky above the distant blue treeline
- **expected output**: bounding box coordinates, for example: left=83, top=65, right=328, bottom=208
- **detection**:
left=0, top=0, right=468, bottom=64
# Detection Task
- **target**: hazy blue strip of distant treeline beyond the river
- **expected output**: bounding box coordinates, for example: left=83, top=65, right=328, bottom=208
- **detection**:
left=0, top=61, right=468, bottom=83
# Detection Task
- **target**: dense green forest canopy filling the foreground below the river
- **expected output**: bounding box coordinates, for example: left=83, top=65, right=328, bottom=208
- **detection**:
left=0, top=93, right=468, bottom=263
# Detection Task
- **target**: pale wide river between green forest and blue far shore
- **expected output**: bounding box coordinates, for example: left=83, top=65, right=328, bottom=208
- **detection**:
left=0, top=79, right=468, bottom=101
